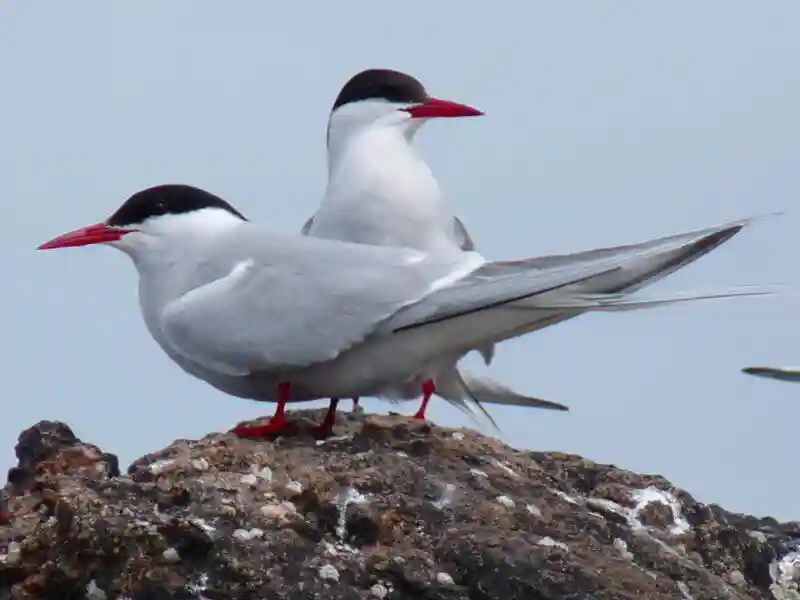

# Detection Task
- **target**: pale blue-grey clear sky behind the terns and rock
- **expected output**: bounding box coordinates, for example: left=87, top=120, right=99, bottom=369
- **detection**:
left=0, top=0, right=800, bottom=519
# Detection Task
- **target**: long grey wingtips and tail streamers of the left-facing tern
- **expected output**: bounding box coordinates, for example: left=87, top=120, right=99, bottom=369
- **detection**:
left=387, top=214, right=774, bottom=341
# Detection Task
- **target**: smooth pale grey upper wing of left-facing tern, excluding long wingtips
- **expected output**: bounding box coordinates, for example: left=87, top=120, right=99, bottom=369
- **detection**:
left=161, top=238, right=466, bottom=375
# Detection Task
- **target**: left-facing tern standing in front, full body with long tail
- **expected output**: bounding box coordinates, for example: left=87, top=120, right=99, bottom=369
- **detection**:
left=39, top=185, right=771, bottom=435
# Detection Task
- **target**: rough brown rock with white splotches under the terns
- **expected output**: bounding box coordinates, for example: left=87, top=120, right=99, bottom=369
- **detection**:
left=0, top=411, right=800, bottom=600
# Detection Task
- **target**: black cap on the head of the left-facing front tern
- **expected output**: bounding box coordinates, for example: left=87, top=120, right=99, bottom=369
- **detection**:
left=106, top=184, right=247, bottom=227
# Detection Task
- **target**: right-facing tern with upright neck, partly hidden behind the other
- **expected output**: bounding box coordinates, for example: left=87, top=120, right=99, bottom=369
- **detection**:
left=302, top=69, right=568, bottom=428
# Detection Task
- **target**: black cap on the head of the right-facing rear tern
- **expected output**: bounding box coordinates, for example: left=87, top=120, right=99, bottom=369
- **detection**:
left=331, top=69, right=429, bottom=112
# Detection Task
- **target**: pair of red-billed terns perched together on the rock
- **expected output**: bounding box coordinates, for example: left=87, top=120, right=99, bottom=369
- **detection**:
left=40, top=69, right=784, bottom=436
